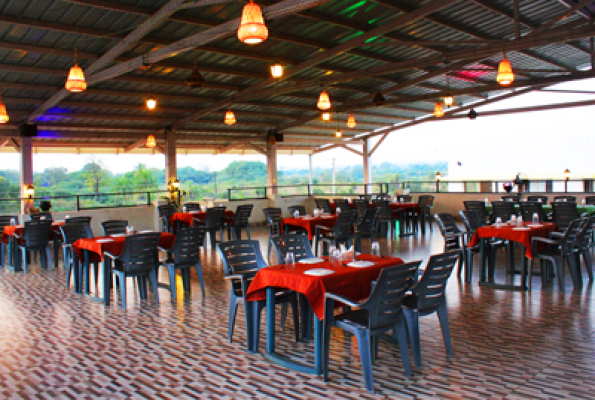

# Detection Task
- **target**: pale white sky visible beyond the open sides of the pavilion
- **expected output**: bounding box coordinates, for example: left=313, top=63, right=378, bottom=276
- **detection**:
left=2, top=79, right=595, bottom=179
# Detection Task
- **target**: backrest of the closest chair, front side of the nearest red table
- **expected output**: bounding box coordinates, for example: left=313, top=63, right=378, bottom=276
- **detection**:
left=362, top=261, right=421, bottom=329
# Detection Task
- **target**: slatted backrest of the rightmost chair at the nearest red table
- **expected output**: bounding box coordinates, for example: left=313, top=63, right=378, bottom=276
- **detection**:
left=414, top=251, right=461, bottom=315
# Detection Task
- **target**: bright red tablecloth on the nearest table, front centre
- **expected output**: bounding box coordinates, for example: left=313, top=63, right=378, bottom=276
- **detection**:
left=247, top=254, right=403, bottom=319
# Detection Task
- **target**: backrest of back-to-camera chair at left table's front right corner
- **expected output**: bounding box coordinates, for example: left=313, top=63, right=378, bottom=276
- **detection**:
left=120, top=232, right=161, bottom=273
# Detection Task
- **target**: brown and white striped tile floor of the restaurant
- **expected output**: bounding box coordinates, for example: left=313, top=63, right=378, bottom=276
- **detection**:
left=0, top=228, right=595, bottom=399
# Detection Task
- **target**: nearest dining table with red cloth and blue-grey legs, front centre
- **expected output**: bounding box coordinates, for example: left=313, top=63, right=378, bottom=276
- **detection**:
left=246, top=254, right=403, bottom=375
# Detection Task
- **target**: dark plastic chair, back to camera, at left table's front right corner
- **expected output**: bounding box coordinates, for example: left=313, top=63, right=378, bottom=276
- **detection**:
left=104, top=232, right=161, bottom=309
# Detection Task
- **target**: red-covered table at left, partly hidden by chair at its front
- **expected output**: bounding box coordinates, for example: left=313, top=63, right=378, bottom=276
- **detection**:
left=72, top=231, right=176, bottom=305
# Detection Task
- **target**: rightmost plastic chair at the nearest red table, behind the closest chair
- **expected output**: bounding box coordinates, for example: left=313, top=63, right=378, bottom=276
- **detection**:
left=399, top=251, right=461, bottom=367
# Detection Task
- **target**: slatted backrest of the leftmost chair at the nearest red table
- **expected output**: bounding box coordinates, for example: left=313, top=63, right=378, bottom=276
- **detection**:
left=217, top=240, right=266, bottom=276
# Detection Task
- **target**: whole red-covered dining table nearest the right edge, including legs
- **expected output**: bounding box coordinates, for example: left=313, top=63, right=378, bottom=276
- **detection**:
left=469, top=222, right=558, bottom=290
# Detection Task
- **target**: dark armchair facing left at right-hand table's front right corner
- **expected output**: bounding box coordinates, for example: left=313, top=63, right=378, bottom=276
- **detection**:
left=529, top=217, right=587, bottom=292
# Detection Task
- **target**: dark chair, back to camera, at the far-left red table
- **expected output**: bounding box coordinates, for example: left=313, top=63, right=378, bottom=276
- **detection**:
left=14, top=219, right=52, bottom=273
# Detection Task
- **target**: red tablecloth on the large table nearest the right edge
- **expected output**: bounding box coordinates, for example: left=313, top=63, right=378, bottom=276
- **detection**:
left=469, top=222, right=558, bottom=259
